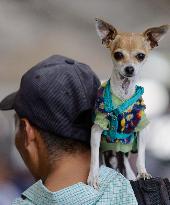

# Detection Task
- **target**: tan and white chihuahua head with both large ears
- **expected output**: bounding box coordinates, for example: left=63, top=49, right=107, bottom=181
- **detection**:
left=96, top=19, right=169, bottom=79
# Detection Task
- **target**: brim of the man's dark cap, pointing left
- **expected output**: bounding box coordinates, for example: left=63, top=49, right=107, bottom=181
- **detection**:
left=0, top=92, right=18, bottom=110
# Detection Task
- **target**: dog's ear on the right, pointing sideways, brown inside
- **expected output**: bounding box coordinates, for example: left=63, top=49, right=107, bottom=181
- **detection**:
left=144, top=25, right=170, bottom=48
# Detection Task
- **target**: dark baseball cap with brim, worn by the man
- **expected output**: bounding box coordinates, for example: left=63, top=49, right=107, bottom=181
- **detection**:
left=0, top=55, right=100, bottom=143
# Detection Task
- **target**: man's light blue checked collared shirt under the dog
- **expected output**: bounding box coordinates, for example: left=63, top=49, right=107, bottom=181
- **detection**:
left=12, top=166, right=137, bottom=205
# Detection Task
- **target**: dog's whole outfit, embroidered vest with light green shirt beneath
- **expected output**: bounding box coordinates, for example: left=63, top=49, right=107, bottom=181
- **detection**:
left=94, top=80, right=149, bottom=153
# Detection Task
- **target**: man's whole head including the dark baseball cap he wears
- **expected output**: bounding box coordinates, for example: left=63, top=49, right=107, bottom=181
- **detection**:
left=0, top=56, right=100, bottom=178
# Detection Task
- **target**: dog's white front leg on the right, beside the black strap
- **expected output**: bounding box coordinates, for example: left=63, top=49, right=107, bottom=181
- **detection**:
left=136, top=129, right=151, bottom=179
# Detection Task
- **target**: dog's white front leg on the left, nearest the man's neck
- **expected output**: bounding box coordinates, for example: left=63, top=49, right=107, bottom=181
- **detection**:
left=87, top=124, right=103, bottom=189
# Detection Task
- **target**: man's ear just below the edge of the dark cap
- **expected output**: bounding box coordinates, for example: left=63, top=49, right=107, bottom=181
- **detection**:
left=20, top=118, right=35, bottom=147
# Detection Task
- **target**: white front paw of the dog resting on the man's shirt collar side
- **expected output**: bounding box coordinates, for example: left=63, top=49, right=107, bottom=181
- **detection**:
left=87, top=170, right=99, bottom=189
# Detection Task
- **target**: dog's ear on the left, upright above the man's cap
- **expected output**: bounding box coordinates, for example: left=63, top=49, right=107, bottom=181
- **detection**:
left=96, top=18, right=117, bottom=47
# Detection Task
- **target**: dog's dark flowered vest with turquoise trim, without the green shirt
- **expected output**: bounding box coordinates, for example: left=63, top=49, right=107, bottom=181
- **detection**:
left=95, top=80, right=146, bottom=144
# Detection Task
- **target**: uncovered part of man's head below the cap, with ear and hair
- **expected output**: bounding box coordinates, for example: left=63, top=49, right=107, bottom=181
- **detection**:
left=15, top=114, right=90, bottom=179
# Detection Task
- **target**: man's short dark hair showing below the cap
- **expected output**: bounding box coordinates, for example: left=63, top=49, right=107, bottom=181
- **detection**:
left=15, top=115, right=90, bottom=160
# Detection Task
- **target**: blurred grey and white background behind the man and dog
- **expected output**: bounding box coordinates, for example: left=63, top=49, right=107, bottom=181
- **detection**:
left=0, top=0, right=170, bottom=205
